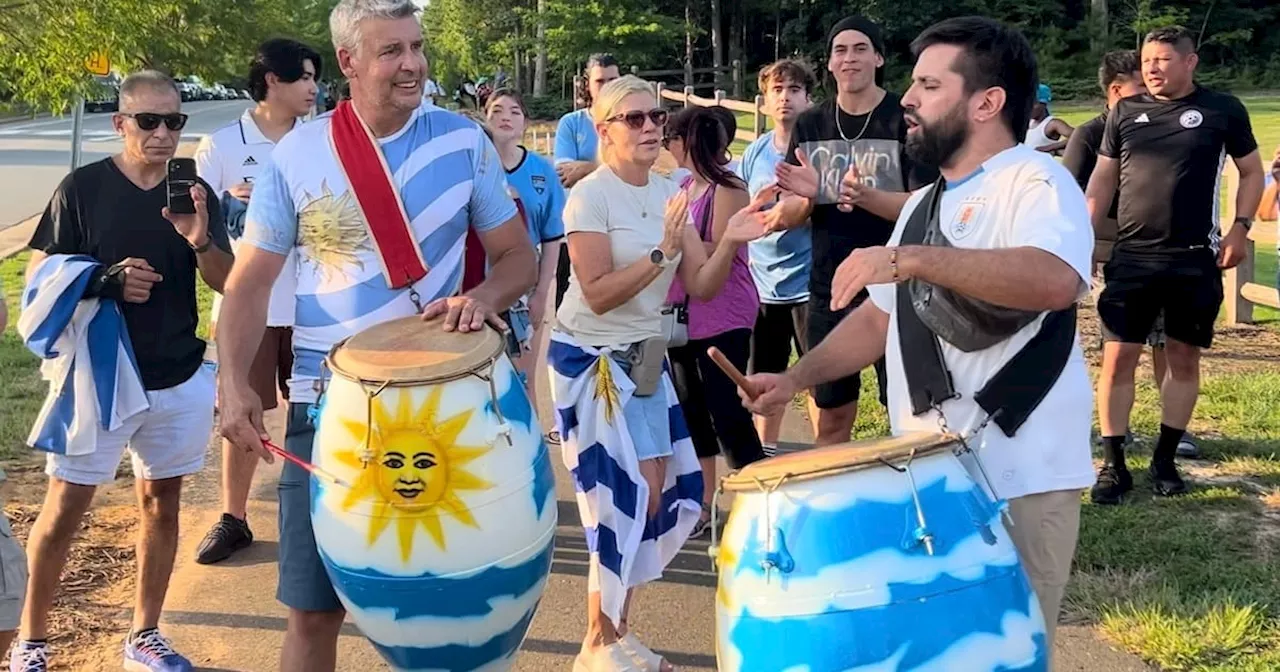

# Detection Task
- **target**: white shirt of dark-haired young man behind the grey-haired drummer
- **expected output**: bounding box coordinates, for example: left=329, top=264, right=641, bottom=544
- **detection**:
left=196, top=109, right=298, bottom=326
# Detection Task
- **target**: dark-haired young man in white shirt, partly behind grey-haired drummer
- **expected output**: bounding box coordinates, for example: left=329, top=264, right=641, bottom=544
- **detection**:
left=196, top=40, right=320, bottom=564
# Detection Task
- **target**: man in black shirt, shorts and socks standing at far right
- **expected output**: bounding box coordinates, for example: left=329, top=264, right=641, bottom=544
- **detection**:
left=1085, top=27, right=1263, bottom=504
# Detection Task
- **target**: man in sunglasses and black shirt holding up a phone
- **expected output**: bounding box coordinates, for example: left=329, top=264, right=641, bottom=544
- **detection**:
left=10, top=72, right=233, bottom=671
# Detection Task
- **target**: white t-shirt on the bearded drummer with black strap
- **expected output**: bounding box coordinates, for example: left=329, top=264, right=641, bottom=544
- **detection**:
left=869, top=145, right=1094, bottom=499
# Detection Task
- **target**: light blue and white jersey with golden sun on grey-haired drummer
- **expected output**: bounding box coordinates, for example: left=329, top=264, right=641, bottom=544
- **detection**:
left=242, top=101, right=516, bottom=403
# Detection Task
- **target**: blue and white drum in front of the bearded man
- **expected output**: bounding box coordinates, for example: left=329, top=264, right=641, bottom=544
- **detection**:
left=713, top=434, right=1048, bottom=672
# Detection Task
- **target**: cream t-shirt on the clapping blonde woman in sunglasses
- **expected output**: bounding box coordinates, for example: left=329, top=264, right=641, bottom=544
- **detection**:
left=556, top=165, right=680, bottom=347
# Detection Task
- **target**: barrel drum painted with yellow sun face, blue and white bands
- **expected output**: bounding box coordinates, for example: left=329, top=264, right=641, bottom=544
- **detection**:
left=311, top=316, right=556, bottom=671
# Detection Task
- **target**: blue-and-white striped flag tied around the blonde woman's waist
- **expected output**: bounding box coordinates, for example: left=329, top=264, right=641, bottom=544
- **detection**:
left=547, top=332, right=703, bottom=625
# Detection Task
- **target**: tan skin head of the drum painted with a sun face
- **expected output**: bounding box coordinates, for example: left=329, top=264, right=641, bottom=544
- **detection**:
left=329, top=315, right=503, bottom=383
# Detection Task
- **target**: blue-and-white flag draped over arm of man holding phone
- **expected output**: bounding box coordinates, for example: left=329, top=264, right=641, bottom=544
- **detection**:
left=18, top=255, right=150, bottom=456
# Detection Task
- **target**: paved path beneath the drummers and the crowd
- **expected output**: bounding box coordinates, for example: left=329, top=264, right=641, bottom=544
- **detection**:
left=140, top=335, right=1148, bottom=672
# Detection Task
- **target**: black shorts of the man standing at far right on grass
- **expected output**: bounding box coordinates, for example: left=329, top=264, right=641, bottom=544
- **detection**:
left=1098, top=248, right=1222, bottom=348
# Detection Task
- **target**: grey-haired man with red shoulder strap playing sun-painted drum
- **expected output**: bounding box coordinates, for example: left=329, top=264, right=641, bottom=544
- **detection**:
left=218, top=0, right=536, bottom=672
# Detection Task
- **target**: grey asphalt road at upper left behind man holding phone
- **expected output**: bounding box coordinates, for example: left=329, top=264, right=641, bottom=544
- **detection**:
left=0, top=100, right=251, bottom=229
